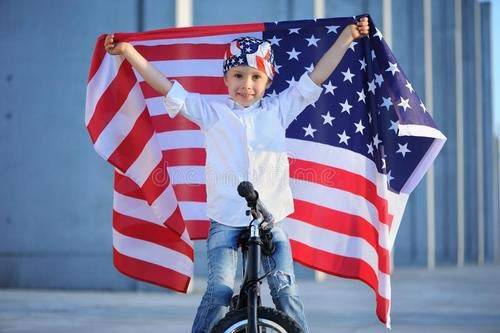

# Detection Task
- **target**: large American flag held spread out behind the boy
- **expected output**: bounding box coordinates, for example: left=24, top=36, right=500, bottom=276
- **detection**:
left=85, top=17, right=446, bottom=326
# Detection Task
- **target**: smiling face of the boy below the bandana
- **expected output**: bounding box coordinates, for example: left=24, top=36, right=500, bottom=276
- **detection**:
left=224, top=66, right=271, bottom=107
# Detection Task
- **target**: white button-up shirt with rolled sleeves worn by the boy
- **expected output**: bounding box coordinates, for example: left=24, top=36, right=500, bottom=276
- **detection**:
left=164, top=73, right=322, bottom=226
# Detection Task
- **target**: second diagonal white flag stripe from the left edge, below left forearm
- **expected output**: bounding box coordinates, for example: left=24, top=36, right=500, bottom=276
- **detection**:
left=94, top=83, right=146, bottom=160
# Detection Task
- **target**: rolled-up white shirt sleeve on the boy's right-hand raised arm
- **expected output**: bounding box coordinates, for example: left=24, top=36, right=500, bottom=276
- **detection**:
left=278, top=72, right=323, bottom=128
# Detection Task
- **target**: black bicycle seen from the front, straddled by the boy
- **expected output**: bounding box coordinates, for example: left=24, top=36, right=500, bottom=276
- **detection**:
left=211, top=182, right=303, bottom=333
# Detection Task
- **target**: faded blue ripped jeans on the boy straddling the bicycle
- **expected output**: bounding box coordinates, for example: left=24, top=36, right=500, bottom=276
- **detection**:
left=192, top=221, right=309, bottom=333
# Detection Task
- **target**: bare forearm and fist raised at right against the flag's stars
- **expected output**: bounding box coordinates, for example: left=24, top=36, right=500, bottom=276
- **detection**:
left=310, top=17, right=369, bottom=86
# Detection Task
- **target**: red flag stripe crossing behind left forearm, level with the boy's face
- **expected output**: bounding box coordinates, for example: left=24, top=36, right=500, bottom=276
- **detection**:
left=140, top=76, right=227, bottom=98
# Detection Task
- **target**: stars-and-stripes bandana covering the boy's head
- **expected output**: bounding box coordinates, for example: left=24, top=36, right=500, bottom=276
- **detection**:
left=223, top=37, right=276, bottom=80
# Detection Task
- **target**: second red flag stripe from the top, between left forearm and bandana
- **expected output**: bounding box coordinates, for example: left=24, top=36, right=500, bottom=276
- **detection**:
left=135, top=44, right=228, bottom=61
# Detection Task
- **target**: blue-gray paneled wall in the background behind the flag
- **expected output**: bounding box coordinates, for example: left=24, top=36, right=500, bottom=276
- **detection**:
left=0, top=0, right=500, bottom=289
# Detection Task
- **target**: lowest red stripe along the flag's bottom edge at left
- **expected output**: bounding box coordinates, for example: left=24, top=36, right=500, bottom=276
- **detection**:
left=113, top=248, right=191, bottom=293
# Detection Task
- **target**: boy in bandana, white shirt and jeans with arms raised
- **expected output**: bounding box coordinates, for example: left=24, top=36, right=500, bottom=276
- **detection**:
left=104, top=18, right=369, bottom=332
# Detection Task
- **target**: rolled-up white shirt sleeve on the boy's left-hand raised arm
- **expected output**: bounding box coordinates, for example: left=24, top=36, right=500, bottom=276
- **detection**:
left=163, top=81, right=218, bottom=130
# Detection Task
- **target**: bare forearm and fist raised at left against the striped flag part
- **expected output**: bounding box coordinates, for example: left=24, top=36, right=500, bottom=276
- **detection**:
left=104, top=34, right=172, bottom=96
